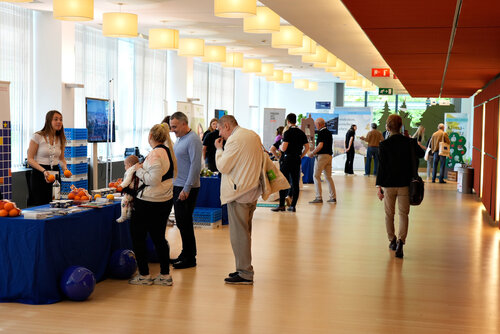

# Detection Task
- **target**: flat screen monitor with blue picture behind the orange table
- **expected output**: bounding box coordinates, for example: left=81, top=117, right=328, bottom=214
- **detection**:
left=85, top=97, right=115, bottom=143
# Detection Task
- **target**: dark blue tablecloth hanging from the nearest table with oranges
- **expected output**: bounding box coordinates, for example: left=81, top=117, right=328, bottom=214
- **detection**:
left=0, top=202, right=132, bottom=304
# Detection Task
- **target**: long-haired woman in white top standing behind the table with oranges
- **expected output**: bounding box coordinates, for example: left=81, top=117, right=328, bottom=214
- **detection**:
left=28, top=110, right=68, bottom=206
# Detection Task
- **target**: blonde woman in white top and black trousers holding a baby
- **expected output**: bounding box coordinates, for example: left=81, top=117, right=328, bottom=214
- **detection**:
left=129, top=124, right=177, bottom=285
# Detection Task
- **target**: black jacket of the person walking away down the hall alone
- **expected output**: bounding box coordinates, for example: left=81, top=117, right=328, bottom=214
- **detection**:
left=377, top=134, right=425, bottom=187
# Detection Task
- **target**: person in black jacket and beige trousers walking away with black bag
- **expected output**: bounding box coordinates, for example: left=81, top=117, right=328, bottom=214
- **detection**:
left=376, top=114, right=425, bottom=258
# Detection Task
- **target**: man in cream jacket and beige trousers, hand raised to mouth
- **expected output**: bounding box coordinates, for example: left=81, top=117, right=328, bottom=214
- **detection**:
left=215, top=115, right=263, bottom=284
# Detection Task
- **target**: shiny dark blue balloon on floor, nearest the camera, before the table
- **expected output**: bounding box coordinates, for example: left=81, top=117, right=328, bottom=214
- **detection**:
left=61, top=266, right=95, bottom=301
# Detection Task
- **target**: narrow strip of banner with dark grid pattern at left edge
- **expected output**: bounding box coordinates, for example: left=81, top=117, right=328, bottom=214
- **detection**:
left=0, top=81, right=12, bottom=200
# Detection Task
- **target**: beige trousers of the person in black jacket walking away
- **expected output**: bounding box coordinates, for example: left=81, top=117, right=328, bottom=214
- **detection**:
left=384, top=187, right=410, bottom=243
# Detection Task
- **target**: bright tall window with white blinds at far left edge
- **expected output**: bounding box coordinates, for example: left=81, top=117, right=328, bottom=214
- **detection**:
left=0, top=3, right=34, bottom=168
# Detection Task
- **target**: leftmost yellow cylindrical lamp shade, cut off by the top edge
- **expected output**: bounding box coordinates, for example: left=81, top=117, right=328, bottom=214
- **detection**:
left=53, top=0, right=94, bottom=21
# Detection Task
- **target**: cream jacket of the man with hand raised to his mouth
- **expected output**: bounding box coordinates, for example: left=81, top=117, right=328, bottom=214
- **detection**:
left=215, top=127, right=262, bottom=204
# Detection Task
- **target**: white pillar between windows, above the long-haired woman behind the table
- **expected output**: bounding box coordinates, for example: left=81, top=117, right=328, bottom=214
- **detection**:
left=33, top=11, right=62, bottom=131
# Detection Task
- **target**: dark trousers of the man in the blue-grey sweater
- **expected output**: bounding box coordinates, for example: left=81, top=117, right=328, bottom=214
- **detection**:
left=174, top=186, right=200, bottom=261
